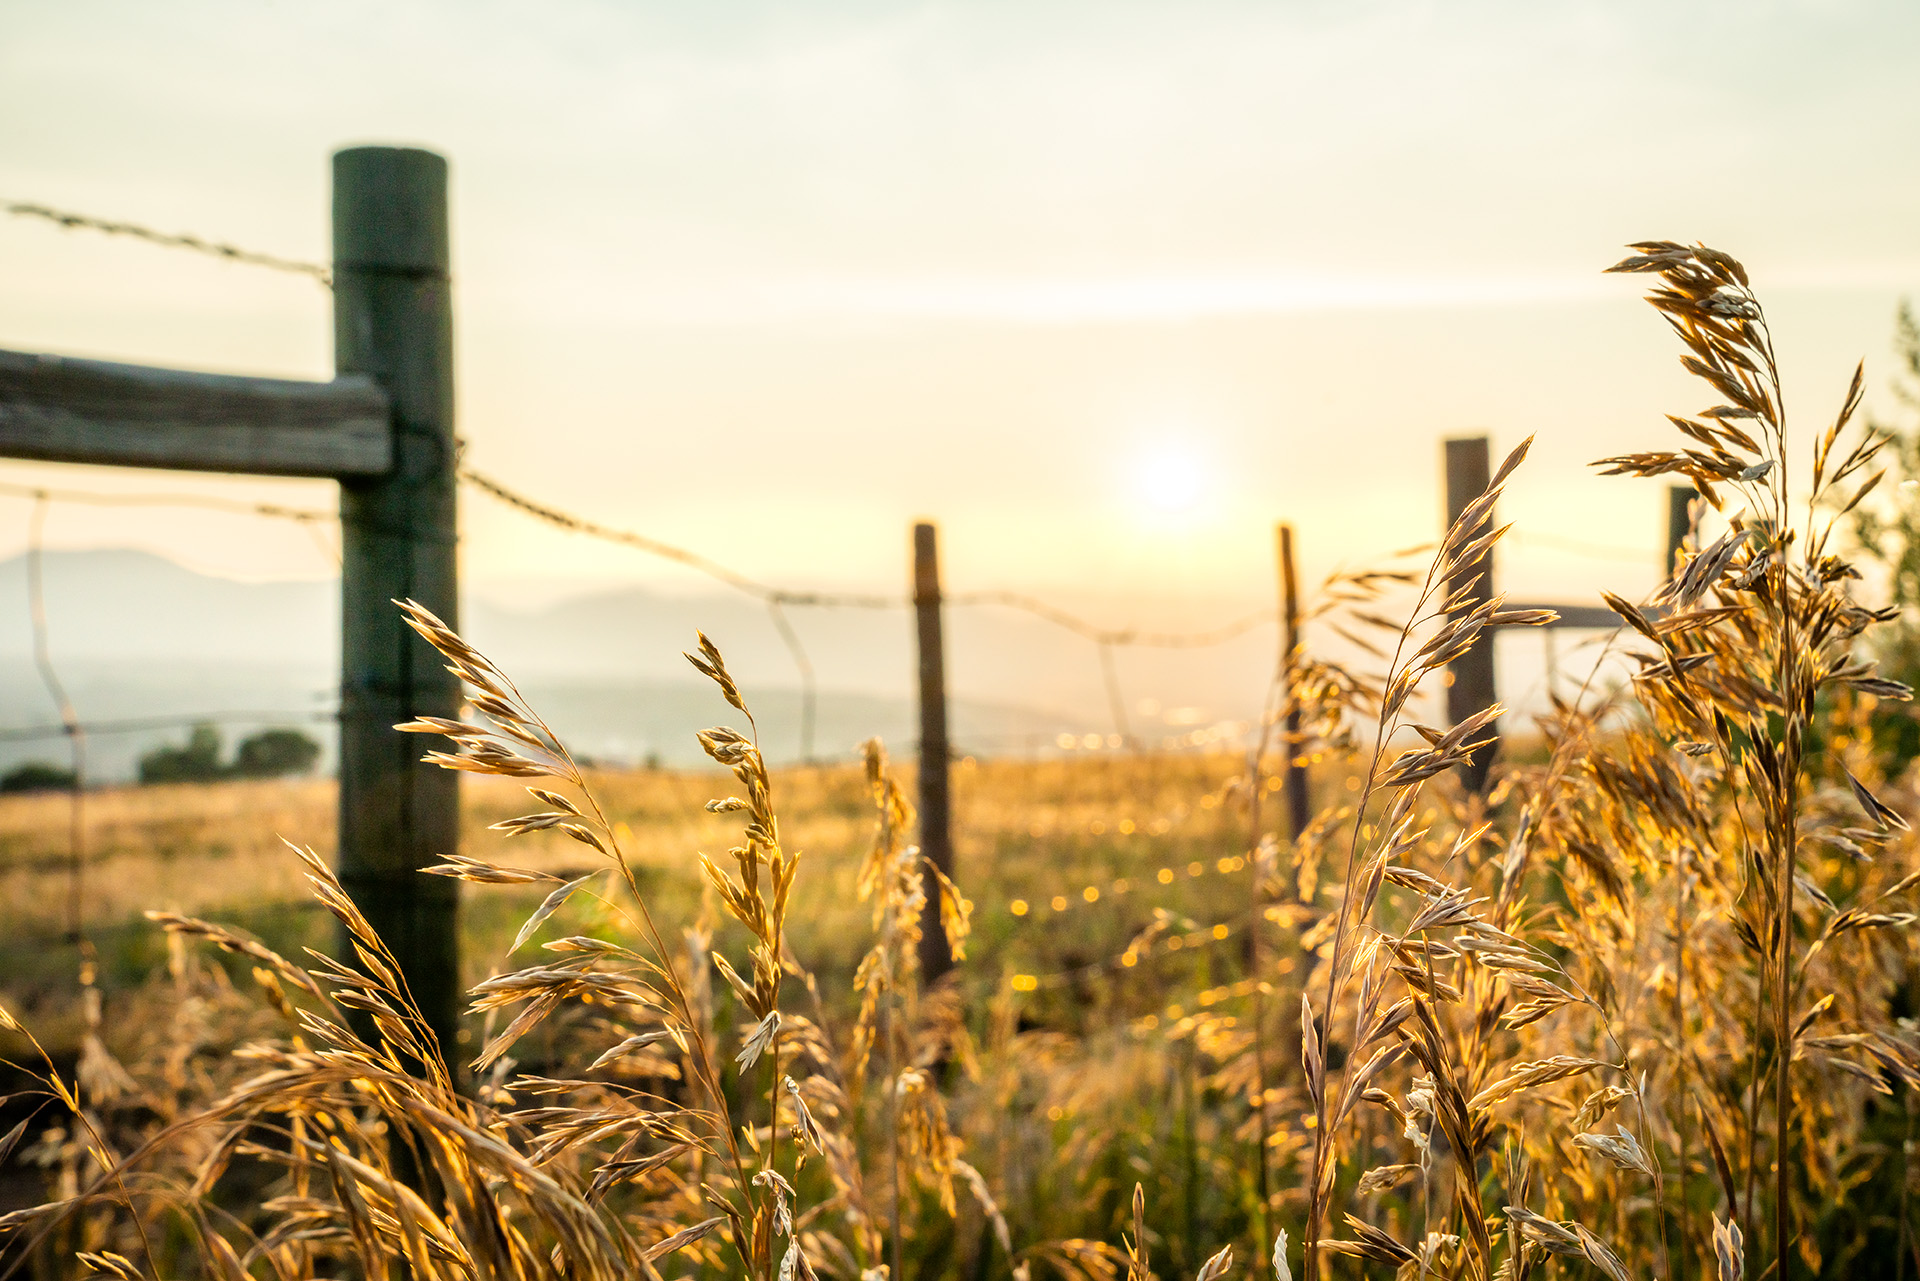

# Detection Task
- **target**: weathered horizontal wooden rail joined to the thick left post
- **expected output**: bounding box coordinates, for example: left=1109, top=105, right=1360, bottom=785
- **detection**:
left=0, top=351, right=394, bottom=476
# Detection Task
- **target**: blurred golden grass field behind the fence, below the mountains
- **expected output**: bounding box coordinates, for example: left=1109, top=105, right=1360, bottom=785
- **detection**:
left=0, top=751, right=1290, bottom=1075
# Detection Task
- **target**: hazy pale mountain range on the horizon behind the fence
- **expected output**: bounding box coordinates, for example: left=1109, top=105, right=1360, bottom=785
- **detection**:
left=0, top=551, right=1271, bottom=780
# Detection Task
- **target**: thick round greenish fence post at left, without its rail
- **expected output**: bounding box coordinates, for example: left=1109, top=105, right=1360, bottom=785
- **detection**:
left=334, top=146, right=463, bottom=1072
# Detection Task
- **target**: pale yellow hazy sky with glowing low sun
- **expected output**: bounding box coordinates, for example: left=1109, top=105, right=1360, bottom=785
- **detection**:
left=0, top=0, right=1920, bottom=624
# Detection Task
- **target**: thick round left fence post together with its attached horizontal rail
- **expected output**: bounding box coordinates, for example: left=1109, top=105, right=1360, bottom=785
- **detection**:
left=0, top=146, right=461, bottom=1058
